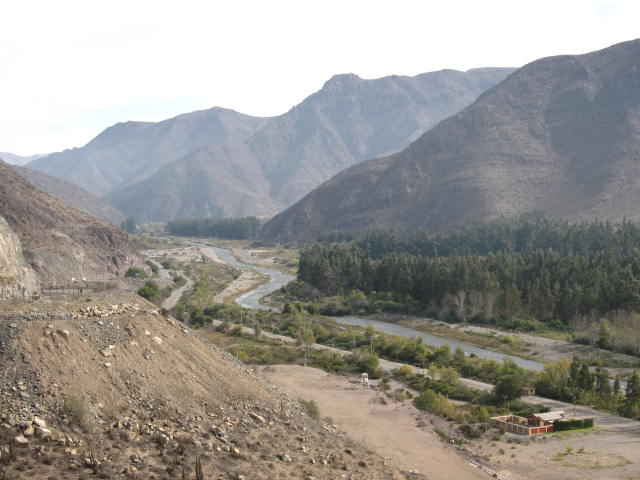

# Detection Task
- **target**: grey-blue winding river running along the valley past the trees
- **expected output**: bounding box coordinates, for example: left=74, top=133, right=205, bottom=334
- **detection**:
left=199, top=242, right=544, bottom=371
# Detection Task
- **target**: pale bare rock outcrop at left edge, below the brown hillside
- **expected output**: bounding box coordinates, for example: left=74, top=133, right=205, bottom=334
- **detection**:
left=0, top=217, right=40, bottom=300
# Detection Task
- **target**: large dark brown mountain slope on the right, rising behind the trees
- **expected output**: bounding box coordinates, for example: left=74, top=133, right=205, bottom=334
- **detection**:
left=262, top=40, right=640, bottom=241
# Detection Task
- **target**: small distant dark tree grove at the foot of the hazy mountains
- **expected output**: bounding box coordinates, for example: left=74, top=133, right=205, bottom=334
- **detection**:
left=167, top=217, right=260, bottom=240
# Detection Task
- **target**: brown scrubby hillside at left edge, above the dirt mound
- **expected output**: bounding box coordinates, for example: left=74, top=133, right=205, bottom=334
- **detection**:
left=0, top=161, right=139, bottom=281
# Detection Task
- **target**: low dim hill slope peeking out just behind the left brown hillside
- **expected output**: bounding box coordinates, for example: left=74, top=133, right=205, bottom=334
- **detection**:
left=11, top=165, right=125, bottom=226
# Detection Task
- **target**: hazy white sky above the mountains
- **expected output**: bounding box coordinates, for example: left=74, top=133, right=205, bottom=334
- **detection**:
left=0, top=0, right=640, bottom=155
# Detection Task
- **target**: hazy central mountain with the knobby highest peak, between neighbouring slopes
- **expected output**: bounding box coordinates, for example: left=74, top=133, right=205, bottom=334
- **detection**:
left=105, top=68, right=513, bottom=221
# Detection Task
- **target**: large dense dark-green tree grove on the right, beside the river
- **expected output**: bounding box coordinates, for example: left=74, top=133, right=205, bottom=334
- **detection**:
left=298, top=215, right=640, bottom=354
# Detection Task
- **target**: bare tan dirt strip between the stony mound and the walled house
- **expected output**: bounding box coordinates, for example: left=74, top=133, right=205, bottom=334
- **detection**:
left=257, top=365, right=490, bottom=480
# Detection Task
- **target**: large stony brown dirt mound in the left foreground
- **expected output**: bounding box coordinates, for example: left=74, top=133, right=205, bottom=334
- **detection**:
left=0, top=293, right=404, bottom=479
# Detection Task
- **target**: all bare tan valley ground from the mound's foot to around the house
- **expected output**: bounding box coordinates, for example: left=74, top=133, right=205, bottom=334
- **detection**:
left=255, top=365, right=640, bottom=480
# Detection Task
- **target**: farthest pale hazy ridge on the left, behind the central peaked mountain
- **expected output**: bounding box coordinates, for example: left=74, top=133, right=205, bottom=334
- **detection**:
left=28, top=107, right=269, bottom=196
